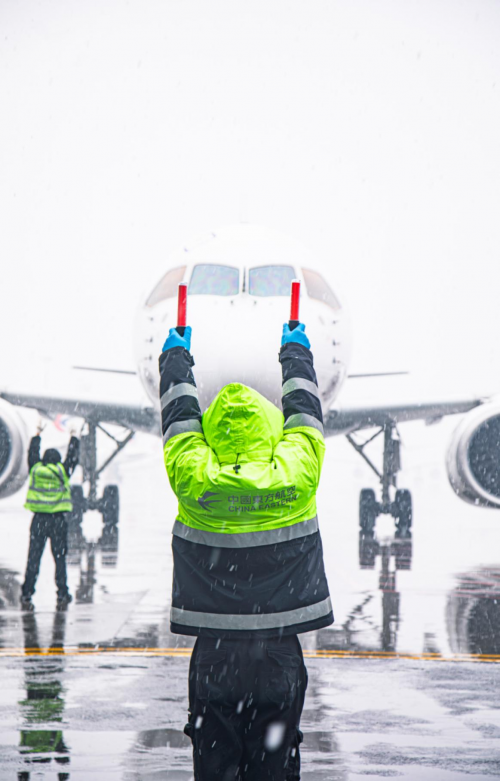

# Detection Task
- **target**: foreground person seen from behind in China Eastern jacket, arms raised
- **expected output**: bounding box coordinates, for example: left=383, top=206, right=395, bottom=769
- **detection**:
left=160, top=325, right=333, bottom=781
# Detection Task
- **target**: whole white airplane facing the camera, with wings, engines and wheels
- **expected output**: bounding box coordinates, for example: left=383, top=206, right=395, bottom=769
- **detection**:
left=0, top=225, right=500, bottom=569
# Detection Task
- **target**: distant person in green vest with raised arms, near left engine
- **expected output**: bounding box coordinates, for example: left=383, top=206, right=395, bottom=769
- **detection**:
left=21, top=436, right=80, bottom=610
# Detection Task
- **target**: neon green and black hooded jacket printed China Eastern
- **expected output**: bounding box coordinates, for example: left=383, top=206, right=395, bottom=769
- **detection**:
left=160, top=345, right=333, bottom=637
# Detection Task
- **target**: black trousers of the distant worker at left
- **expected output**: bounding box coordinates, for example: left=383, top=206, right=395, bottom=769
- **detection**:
left=22, top=513, right=68, bottom=597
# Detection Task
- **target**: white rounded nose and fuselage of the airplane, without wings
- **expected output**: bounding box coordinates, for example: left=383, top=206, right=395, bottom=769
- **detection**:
left=136, top=226, right=350, bottom=418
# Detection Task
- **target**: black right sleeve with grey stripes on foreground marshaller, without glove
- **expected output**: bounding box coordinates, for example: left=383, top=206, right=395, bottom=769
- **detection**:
left=279, top=342, right=323, bottom=430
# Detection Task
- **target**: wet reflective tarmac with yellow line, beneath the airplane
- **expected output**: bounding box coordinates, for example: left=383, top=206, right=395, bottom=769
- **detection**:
left=0, top=427, right=500, bottom=781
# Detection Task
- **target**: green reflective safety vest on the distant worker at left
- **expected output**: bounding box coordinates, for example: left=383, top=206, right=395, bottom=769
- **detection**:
left=24, top=461, right=73, bottom=513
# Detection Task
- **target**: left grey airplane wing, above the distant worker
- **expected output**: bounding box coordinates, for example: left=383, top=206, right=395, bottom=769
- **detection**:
left=0, top=391, right=161, bottom=435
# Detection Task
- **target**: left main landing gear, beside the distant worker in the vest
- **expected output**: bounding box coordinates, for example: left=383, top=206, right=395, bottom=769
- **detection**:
left=69, top=421, right=134, bottom=528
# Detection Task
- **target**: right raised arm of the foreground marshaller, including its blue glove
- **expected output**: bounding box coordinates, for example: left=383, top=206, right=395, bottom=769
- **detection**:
left=275, top=324, right=325, bottom=486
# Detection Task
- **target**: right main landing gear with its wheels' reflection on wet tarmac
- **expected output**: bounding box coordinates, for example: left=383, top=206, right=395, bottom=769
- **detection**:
left=347, top=423, right=413, bottom=569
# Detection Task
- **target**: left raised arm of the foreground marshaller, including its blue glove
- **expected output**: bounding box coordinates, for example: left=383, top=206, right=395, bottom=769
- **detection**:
left=160, top=326, right=210, bottom=494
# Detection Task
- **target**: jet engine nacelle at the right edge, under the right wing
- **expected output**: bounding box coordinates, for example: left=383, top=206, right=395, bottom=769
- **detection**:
left=446, top=404, right=500, bottom=507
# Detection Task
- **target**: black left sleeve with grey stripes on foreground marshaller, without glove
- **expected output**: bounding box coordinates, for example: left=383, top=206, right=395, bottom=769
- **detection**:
left=160, top=347, right=202, bottom=444
